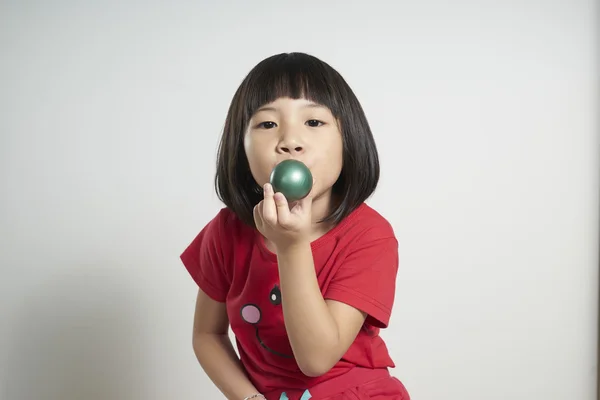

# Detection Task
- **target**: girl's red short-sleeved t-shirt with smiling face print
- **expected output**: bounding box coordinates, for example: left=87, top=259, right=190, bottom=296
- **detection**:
left=181, top=203, right=398, bottom=392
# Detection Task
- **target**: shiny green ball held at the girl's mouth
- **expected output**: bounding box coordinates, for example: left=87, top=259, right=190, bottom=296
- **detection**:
left=270, top=160, right=313, bottom=201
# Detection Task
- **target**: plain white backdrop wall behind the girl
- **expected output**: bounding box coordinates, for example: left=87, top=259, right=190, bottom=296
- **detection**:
left=0, top=0, right=600, bottom=400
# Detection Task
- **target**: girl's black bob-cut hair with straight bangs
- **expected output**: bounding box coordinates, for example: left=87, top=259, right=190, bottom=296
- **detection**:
left=215, top=53, right=379, bottom=226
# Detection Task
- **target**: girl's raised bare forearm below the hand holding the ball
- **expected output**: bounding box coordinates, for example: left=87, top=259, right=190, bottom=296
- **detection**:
left=277, top=243, right=339, bottom=376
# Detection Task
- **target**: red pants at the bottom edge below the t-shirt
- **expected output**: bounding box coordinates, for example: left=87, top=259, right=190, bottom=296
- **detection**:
left=265, top=368, right=410, bottom=400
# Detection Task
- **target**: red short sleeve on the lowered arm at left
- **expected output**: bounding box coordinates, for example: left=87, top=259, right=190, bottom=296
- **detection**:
left=180, top=210, right=230, bottom=303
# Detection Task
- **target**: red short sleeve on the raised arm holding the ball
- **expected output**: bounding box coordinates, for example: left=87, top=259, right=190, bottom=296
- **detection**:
left=324, top=236, right=398, bottom=328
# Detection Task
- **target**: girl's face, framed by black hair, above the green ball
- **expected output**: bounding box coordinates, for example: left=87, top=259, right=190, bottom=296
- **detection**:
left=244, top=98, right=343, bottom=203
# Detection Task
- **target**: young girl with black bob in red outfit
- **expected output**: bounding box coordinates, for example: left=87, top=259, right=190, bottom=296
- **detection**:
left=181, top=53, right=409, bottom=400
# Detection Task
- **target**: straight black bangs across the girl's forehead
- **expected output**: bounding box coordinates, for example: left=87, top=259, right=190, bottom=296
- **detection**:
left=242, top=53, right=342, bottom=121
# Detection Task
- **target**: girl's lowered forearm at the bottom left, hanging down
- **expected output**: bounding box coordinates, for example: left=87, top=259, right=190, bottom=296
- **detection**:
left=193, top=334, right=258, bottom=400
